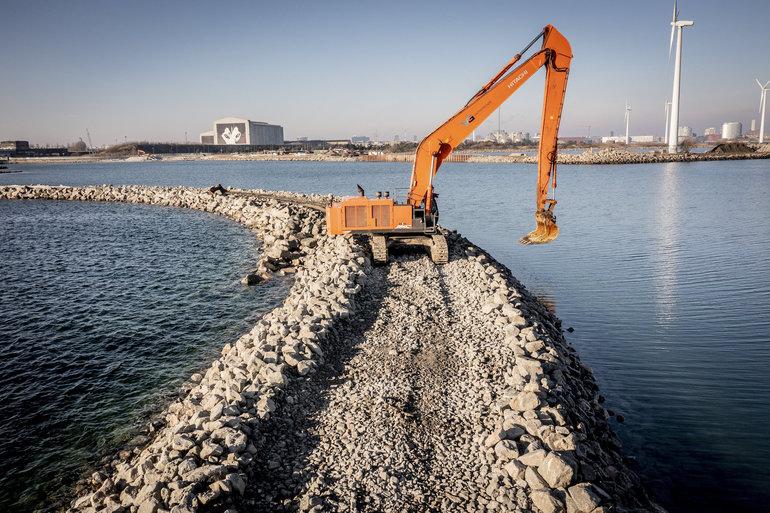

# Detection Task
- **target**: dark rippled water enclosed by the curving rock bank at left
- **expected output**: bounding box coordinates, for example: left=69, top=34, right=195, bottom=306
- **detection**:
left=0, top=201, right=284, bottom=511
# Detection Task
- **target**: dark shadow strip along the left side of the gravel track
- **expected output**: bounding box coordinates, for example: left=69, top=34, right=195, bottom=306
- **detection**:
left=236, top=267, right=389, bottom=511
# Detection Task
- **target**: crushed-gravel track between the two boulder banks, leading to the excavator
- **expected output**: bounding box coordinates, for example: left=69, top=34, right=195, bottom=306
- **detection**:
left=240, top=250, right=487, bottom=511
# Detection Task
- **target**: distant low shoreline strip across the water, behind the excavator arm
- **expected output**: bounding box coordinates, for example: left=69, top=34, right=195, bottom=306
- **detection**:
left=9, top=148, right=770, bottom=165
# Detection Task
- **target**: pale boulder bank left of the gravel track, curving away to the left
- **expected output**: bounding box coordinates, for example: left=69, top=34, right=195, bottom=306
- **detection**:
left=0, top=186, right=369, bottom=513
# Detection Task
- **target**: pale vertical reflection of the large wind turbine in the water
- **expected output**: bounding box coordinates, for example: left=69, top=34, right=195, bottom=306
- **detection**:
left=653, top=163, right=682, bottom=327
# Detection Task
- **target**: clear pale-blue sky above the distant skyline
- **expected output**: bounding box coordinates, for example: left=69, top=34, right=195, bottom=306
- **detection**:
left=0, top=0, right=770, bottom=145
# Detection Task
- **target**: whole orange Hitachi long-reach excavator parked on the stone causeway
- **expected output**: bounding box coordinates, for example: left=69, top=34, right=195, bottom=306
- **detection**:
left=326, top=25, right=572, bottom=264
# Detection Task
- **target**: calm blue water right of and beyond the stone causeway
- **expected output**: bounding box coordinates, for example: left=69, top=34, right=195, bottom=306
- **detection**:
left=0, top=161, right=770, bottom=512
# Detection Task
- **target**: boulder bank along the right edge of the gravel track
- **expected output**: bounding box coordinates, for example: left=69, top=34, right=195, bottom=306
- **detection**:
left=452, top=239, right=662, bottom=513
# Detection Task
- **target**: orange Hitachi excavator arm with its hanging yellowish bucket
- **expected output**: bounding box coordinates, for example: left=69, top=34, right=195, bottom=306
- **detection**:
left=407, top=25, right=572, bottom=244
